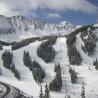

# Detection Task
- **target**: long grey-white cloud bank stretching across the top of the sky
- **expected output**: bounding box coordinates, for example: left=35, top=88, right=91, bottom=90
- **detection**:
left=0, top=0, right=98, bottom=17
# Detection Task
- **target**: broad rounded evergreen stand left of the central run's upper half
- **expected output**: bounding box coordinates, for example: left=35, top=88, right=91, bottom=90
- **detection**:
left=37, top=38, right=56, bottom=63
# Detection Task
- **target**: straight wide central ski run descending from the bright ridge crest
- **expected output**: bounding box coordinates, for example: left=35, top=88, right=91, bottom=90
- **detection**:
left=54, top=37, right=71, bottom=92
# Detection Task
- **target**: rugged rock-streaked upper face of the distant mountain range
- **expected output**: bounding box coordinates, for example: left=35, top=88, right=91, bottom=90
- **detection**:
left=0, top=16, right=75, bottom=34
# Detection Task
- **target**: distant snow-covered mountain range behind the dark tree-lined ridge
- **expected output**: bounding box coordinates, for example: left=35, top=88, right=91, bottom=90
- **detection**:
left=0, top=15, right=75, bottom=39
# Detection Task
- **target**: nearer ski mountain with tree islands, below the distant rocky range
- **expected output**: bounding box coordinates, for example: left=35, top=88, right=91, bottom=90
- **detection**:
left=0, top=22, right=98, bottom=98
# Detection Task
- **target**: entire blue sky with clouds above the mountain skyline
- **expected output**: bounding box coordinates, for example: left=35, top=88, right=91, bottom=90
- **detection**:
left=0, top=0, right=98, bottom=25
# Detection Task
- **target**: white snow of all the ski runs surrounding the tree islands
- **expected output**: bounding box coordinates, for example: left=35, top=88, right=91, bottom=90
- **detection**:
left=0, top=34, right=98, bottom=98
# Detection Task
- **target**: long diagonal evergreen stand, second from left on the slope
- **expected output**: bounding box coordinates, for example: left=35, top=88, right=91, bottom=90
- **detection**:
left=23, top=51, right=45, bottom=84
